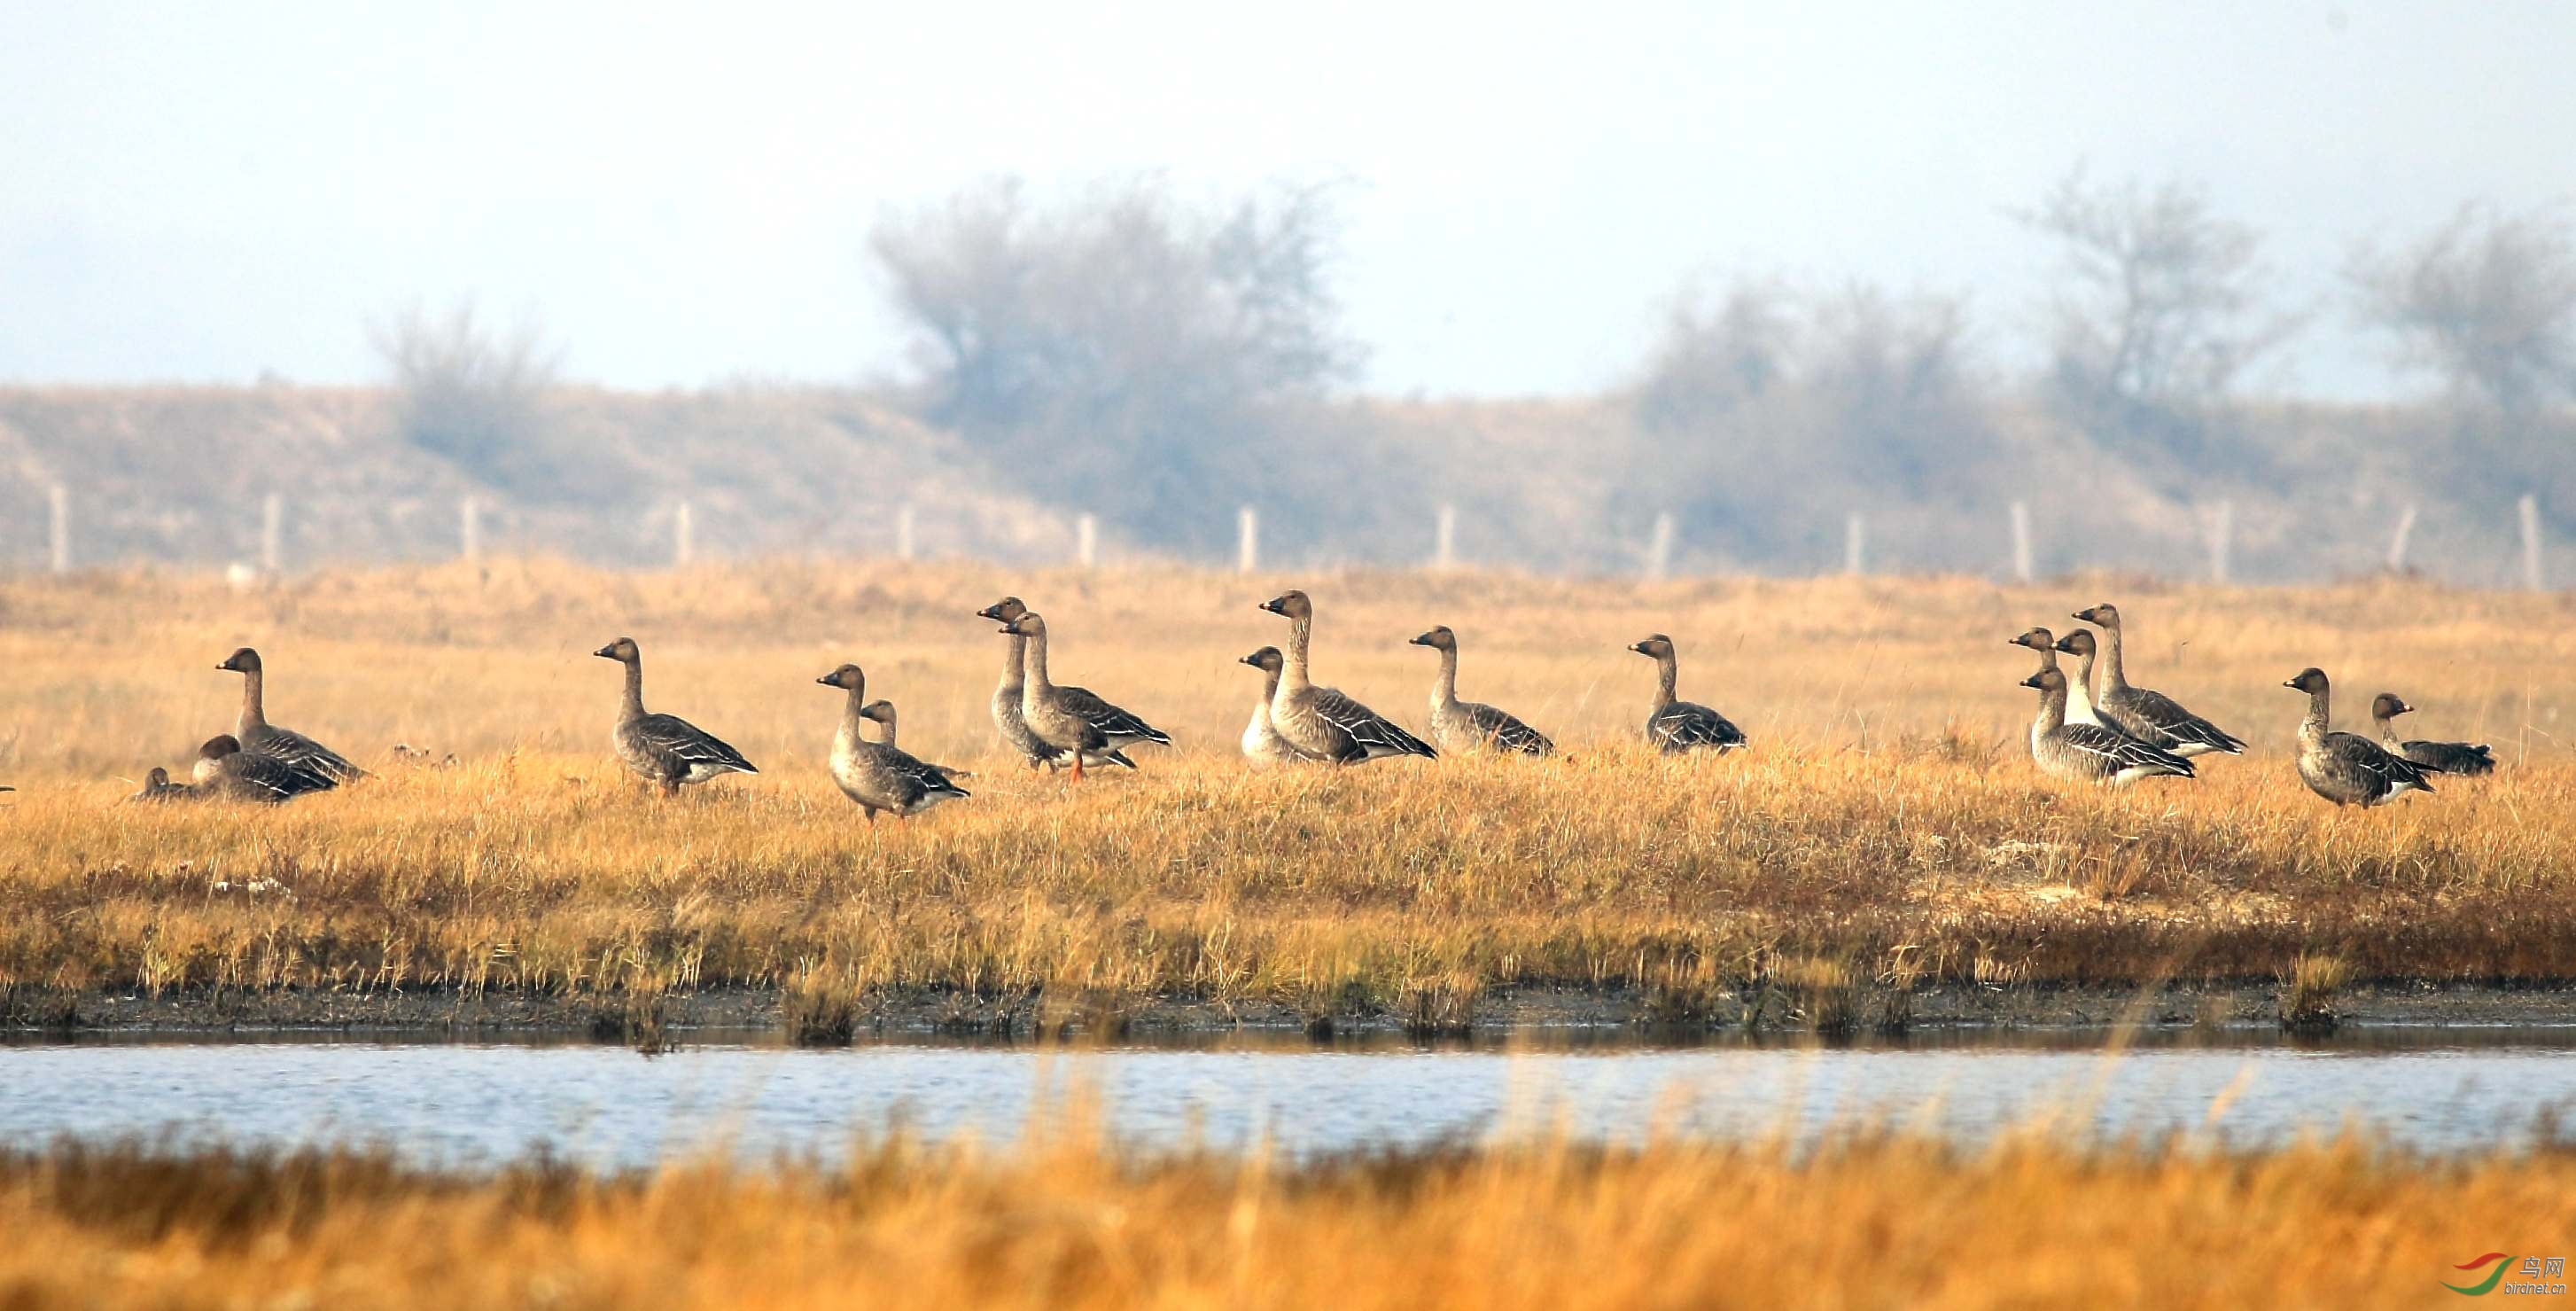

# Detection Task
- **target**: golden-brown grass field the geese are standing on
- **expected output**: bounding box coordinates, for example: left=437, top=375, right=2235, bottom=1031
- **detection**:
left=0, top=561, right=2576, bottom=1014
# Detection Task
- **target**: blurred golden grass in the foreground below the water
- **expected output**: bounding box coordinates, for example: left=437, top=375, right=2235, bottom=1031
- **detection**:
left=0, top=1112, right=2576, bottom=1308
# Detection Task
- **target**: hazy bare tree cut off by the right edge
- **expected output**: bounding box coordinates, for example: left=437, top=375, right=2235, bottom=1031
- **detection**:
left=2346, top=204, right=2576, bottom=417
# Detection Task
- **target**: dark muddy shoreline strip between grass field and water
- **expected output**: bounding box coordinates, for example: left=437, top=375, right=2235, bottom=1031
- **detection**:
left=15, top=981, right=2576, bottom=1041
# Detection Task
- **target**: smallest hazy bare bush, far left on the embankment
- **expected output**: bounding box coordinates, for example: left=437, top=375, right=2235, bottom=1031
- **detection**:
left=369, top=301, right=562, bottom=484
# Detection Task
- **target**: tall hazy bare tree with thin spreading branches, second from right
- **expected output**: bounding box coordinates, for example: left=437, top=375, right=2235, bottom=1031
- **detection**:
left=2014, top=168, right=2295, bottom=450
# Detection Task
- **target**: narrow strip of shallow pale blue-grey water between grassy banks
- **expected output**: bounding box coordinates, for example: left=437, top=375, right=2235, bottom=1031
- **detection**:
left=0, top=1027, right=2576, bottom=1164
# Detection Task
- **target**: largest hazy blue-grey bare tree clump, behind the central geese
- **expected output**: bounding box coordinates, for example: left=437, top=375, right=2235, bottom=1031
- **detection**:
left=871, top=177, right=1360, bottom=546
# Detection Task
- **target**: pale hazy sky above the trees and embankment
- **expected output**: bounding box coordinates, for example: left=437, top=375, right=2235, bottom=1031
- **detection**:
left=0, top=0, right=2576, bottom=396
